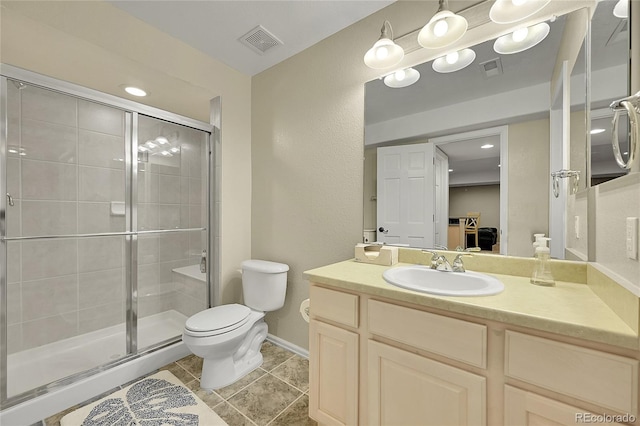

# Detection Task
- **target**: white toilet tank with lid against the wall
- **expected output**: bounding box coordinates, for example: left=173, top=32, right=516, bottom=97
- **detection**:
left=242, top=259, right=289, bottom=312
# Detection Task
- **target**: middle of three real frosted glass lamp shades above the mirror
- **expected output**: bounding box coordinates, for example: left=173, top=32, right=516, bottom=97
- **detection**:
left=418, top=0, right=469, bottom=49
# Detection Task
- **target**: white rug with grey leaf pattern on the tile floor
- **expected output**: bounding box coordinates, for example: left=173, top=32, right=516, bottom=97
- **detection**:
left=60, top=371, right=226, bottom=426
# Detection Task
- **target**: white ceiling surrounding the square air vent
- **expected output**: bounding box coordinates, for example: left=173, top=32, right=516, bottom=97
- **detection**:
left=110, top=0, right=395, bottom=76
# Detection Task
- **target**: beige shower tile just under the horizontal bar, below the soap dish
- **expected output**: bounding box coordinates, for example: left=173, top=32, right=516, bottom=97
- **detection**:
left=78, top=237, right=124, bottom=272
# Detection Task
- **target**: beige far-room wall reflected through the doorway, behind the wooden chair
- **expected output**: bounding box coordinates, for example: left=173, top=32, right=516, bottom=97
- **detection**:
left=449, top=185, right=500, bottom=233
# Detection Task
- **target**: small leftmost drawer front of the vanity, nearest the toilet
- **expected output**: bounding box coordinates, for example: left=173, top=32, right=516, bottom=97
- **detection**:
left=309, top=285, right=358, bottom=328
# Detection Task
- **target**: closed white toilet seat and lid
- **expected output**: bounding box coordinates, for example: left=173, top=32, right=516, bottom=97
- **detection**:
left=184, top=303, right=251, bottom=337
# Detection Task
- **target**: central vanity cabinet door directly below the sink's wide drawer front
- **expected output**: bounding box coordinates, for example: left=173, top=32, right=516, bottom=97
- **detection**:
left=368, top=340, right=486, bottom=426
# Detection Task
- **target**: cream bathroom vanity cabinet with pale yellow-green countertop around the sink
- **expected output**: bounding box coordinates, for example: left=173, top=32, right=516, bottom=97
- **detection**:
left=305, top=250, right=640, bottom=426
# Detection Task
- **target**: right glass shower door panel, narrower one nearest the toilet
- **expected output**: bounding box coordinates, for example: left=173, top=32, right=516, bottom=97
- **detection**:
left=136, top=115, right=209, bottom=349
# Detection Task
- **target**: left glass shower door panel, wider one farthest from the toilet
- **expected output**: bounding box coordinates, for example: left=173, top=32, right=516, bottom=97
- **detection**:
left=2, top=80, right=128, bottom=397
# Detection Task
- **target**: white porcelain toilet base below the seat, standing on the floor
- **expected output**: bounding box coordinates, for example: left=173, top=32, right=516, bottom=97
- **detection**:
left=200, top=319, right=267, bottom=390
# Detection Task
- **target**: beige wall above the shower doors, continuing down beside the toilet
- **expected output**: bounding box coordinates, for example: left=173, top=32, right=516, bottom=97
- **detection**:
left=0, top=1, right=251, bottom=301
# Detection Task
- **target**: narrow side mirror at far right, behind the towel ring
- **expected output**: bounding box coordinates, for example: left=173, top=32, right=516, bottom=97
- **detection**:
left=591, top=0, right=630, bottom=186
